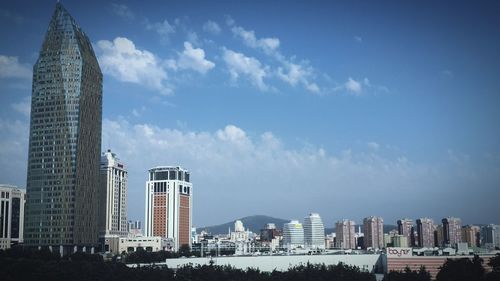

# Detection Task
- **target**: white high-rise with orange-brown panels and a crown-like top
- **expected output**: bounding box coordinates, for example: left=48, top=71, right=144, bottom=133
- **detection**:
left=144, top=166, right=193, bottom=250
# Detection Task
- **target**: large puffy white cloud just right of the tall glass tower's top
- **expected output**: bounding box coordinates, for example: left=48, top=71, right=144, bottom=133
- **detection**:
left=96, top=37, right=172, bottom=94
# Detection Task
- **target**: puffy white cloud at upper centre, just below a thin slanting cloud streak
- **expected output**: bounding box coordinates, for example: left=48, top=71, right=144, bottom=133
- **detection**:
left=223, top=49, right=268, bottom=91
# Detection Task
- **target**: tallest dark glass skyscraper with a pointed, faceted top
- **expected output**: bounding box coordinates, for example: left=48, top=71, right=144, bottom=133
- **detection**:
left=24, top=2, right=102, bottom=254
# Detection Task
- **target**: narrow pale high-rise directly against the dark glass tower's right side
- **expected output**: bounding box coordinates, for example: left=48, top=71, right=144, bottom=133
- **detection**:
left=99, top=150, right=128, bottom=240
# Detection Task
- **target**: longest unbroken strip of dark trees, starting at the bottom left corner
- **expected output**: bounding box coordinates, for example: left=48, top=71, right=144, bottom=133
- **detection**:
left=0, top=248, right=375, bottom=281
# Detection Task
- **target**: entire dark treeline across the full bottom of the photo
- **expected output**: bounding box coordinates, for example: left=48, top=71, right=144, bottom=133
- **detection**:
left=0, top=247, right=500, bottom=281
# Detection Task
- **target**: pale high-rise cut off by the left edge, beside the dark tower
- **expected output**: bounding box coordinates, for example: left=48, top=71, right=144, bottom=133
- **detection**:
left=0, top=184, right=26, bottom=250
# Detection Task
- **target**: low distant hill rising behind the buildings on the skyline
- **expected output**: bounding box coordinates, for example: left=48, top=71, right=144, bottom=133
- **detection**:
left=197, top=215, right=290, bottom=234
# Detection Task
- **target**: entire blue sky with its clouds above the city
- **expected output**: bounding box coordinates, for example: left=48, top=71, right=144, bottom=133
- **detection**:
left=0, top=0, right=500, bottom=227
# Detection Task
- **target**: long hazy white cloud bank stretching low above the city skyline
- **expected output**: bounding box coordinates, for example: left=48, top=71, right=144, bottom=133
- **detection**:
left=98, top=119, right=500, bottom=226
